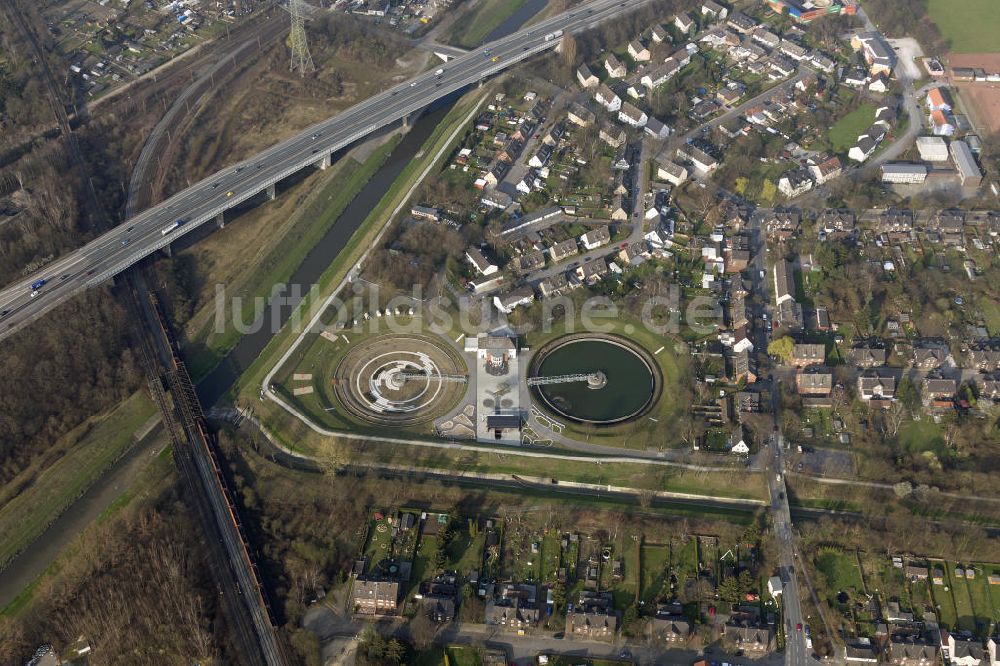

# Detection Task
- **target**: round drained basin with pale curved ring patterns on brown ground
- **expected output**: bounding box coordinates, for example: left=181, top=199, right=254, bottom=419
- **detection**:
left=331, top=335, right=468, bottom=426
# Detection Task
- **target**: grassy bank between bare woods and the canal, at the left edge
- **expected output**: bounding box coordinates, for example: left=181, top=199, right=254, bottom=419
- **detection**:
left=0, top=391, right=156, bottom=564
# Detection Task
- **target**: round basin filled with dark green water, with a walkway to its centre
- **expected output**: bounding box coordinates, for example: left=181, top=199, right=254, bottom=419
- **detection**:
left=528, top=334, right=662, bottom=425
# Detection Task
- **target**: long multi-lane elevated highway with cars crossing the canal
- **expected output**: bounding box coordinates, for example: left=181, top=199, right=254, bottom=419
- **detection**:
left=0, top=0, right=646, bottom=338
